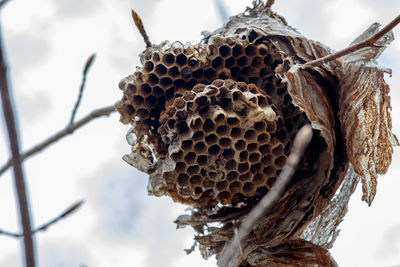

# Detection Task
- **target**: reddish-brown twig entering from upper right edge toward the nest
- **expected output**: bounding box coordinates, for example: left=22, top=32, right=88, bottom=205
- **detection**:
left=304, top=15, right=400, bottom=67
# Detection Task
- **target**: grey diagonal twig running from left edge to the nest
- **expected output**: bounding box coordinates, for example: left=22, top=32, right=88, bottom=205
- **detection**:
left=0, top=106, right=115, bottom=176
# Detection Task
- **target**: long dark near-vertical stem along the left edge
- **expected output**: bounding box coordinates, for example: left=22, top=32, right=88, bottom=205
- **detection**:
left=0, top=25, right=36, bottom=267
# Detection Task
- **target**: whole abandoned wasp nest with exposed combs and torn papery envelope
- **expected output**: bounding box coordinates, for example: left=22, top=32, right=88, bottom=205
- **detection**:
left=116, top=1, right=396, bottom=266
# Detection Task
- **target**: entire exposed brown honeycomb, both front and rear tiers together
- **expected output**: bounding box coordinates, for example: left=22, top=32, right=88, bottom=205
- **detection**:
left=116, top=30, right=309, bottom=207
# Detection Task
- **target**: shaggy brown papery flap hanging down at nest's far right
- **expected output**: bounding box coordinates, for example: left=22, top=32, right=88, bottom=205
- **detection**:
left=338, top=23, right=397, bottom=205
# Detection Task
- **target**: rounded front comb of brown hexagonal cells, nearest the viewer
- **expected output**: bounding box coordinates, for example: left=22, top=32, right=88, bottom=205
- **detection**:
left=155, top=79, right=296, bottom=207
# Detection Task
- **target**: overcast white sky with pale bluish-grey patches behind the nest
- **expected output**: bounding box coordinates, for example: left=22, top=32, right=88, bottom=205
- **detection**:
left=0, top=0, right=400, bottom=267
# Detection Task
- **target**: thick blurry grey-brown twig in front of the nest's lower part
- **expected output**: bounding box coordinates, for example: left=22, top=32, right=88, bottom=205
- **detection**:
left=218, top=125, right=312, bottom=267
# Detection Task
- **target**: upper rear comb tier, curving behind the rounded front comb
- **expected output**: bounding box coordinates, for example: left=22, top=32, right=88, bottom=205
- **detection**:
left=116, top=35, right=288, bottom=136
